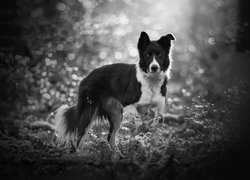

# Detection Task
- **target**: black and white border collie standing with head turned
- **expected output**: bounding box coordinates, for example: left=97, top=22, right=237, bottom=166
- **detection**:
left=55, top=32, right=175, bottom=158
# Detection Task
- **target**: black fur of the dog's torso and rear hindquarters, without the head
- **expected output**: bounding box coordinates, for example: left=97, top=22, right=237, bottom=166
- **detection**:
left=62, top=64, right=141, bottom=146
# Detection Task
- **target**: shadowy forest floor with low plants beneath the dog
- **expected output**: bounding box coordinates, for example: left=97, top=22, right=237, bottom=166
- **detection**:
left=0, top=90, right=250, bottom=179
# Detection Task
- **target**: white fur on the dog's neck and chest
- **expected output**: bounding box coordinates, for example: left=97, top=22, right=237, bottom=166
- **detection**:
left=135, top=64, right=166, bottom=115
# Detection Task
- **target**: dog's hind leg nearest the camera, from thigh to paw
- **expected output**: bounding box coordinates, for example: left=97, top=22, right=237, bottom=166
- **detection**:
left=102, top=98, right=123, bottom=160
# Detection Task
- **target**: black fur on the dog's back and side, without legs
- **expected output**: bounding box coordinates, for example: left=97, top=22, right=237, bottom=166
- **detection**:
left=78, top=63, right=141, bottom=109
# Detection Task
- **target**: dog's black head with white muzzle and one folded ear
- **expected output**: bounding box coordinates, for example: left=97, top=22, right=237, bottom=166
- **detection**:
left=138, top=32, right=175, bottom=75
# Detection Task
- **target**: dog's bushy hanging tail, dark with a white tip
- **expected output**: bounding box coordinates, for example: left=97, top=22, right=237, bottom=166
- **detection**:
left=54, top=105, right=76, bottom=145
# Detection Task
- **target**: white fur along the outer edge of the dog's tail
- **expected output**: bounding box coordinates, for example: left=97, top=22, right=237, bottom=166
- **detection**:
left=54, top=105, right=74, bottom=144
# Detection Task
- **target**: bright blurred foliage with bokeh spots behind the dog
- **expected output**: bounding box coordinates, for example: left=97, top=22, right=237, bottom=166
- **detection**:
left=2, top=0, right=245, bottom=117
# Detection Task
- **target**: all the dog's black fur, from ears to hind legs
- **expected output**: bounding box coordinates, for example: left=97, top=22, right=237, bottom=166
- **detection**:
left=56, top=32, right=174, bottom=155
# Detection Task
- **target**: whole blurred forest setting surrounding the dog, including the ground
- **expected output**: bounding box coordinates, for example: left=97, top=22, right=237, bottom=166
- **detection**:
left=0, top=0, right=250, bottom=179
